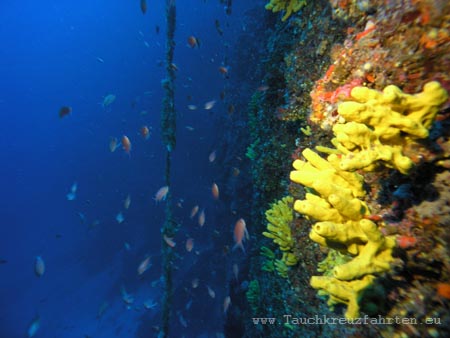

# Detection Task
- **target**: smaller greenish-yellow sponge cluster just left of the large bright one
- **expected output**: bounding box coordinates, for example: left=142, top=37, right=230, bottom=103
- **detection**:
left=263, top=196, right=298, bottom=276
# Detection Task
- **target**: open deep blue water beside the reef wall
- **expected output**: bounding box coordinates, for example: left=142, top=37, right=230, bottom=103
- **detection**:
left=0, top=0, right=262, bottom=338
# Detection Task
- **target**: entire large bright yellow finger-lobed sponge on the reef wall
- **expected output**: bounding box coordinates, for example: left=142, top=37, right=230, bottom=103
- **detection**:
left=290, top=82, right=448, bottom=318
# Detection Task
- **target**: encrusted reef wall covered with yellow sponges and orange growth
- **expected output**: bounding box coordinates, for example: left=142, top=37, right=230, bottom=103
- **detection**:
left=245, top=0, right=450, bottom=337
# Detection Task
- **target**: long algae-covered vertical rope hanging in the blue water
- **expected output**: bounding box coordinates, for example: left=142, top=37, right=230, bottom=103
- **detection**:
left=160, top=0, right=178, bottom=337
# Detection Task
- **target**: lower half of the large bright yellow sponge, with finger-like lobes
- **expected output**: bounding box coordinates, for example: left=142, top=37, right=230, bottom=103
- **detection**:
left=290, top=149, right=395, bottom=318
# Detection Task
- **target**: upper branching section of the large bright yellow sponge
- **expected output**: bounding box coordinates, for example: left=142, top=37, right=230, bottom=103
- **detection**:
left=332, top=81, right=448, bottom=174
